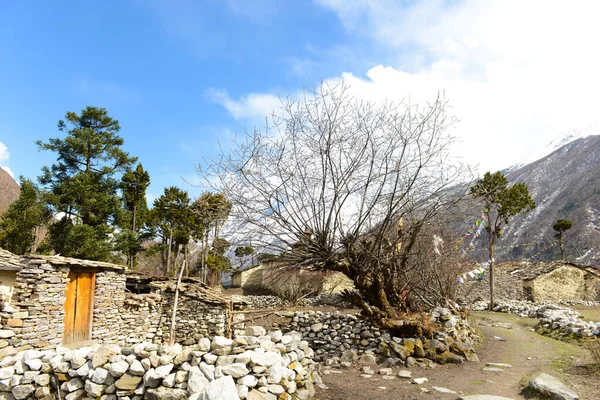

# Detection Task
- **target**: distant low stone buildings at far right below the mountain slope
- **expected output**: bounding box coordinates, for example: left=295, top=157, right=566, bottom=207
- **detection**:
left=458, top=261, right=600, bottom=304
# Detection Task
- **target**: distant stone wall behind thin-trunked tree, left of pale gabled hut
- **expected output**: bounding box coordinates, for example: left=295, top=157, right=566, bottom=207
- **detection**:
left=457, top=270, right=524, bottom=304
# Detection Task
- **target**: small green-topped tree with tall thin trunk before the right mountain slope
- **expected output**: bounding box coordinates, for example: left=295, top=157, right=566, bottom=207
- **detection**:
left=471, top=172, right=535, bottom=310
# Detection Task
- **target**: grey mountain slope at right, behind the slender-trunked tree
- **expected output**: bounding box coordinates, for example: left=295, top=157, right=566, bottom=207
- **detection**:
left=478, top=136, right=600, bottom=266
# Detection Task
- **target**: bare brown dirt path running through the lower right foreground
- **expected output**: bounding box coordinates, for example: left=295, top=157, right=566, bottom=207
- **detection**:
left=317, top=312, right=600, bottom=400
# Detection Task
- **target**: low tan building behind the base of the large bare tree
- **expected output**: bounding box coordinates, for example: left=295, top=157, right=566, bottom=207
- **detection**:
left=231, top=258, right=354, bottom=293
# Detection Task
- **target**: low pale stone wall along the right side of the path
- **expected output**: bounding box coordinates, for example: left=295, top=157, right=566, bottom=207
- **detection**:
left=471, top=300, right=600, bottom=338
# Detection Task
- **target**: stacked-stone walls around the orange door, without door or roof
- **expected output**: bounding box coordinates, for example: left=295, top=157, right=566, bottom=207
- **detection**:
left=0, top=257, right=244, bottom=354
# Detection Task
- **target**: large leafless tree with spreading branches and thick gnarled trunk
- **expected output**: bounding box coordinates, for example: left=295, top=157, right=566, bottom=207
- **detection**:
left=198, top=84, right=465, bottom=326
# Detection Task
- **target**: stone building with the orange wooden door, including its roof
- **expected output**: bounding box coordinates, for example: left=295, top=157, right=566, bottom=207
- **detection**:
left=0, top=250, right=243, bottom=351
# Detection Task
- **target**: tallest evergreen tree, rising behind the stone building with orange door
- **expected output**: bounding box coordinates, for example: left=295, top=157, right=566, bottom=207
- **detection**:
left=36, top=106, right=136, bottom=260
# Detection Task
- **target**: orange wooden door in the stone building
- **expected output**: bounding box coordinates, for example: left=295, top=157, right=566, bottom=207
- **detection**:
left=63, top=271, right=96, bottom=344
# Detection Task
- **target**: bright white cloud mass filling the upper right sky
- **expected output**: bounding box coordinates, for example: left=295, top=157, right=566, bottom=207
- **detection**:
left=216, top=0, right=600, bottom=171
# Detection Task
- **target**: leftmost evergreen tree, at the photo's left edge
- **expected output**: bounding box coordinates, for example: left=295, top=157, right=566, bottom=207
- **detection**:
left=0, top=177, right=51, bottom=254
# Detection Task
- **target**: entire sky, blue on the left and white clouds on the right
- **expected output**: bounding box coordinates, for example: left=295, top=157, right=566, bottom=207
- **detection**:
left=0, top=0, right=600, bottom=200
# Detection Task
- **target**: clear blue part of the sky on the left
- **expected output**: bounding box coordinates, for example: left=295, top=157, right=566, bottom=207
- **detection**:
left=0, top=0, right=370, bottom=200
